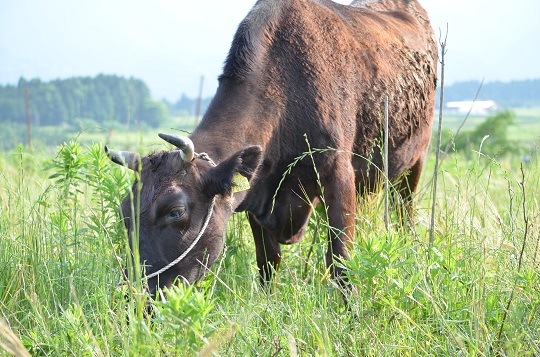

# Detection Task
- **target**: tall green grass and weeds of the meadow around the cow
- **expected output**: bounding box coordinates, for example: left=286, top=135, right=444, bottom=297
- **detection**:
left=0, top=134, right=540, bottom=356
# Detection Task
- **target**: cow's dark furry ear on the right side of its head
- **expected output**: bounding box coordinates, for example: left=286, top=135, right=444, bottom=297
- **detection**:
left=203, top=146, right=262, bottom=197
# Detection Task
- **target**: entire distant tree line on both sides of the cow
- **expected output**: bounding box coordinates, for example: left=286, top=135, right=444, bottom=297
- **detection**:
left=0, top=75, right=540, bottom=127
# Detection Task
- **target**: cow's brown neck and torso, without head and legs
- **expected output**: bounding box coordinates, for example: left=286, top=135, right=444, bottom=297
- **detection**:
left=196, top=0, right=437, bottom=217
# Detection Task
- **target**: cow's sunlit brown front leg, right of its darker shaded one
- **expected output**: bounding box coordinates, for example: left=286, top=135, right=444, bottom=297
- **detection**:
left=323, top=160, right=356, bottom=286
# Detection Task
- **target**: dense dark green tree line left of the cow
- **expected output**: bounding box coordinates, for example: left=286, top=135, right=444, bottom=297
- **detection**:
left=0, top=75, right=168, bottom=127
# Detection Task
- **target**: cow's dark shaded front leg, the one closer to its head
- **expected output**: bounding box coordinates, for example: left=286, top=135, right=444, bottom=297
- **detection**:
left=248, top=213, right=281, bottom=286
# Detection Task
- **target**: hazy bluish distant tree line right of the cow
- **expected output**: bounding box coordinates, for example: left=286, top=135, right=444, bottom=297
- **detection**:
left=437, top=79, right=540, bottom=108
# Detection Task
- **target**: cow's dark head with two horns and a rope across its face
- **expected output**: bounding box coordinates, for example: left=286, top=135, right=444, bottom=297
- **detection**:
left=105, top=134, right=261, bottom=294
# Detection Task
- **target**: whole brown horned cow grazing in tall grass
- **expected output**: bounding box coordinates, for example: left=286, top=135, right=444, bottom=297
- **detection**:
left=109, top=0, right=437, bottom=291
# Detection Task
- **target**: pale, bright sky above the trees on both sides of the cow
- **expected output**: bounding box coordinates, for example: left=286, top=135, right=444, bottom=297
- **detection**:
left=0, top=0, right=540, bottom=101
